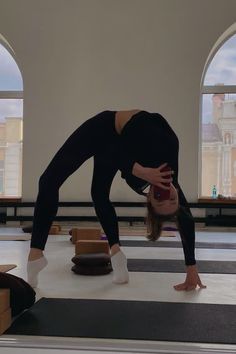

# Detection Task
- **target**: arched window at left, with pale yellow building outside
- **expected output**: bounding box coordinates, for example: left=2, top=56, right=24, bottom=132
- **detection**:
left=0, top=35, right=23, bottom=198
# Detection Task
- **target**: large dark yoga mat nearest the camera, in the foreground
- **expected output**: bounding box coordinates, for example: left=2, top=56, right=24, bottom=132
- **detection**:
left=6, top=298, right=236, bottom=344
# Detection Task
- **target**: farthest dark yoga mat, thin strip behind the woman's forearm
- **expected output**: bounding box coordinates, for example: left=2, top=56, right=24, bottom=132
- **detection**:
left=121, top=240, right=236, bottom=249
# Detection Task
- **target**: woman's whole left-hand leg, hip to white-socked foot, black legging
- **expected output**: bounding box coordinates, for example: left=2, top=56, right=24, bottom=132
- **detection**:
left=27, top=111, right=115, bottom=286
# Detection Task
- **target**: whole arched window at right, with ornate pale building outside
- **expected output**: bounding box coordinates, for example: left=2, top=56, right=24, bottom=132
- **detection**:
left=200, top=33, right=236, bottom=197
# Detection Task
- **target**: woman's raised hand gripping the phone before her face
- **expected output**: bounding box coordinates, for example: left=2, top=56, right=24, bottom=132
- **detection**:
left=132, top=162, right=174, bottom=189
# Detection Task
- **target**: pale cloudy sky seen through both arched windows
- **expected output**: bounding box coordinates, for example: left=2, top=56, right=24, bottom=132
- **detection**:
left=0, top=34, right=236, bottom=123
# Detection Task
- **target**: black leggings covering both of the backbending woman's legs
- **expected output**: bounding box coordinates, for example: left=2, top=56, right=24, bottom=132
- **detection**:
left=31, top=111, right=119, bottom=250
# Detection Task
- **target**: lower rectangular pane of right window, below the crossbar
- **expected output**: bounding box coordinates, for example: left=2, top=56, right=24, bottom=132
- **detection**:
left=201, top=93, right=236, bottom=197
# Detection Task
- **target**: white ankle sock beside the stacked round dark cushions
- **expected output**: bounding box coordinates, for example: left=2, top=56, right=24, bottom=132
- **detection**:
left=111, top=251, right=129, bottom=284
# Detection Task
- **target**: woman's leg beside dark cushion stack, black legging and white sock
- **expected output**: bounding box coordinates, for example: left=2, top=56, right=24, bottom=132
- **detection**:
left=91, top=151, right=129, bottom=284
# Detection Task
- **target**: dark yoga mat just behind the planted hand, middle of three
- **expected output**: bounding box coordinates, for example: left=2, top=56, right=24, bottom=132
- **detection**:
left=128, top=259, right=236, bottom=276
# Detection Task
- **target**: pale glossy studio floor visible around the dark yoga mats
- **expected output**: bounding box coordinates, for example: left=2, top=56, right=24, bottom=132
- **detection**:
left=0, top=227, right=236, bottom=354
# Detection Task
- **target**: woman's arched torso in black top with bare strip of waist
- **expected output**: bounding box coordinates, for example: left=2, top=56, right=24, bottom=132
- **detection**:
left=115, top=110, right=178, bottom=183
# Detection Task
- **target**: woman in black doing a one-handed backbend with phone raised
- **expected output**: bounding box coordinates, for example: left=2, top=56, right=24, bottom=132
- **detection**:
left=27, top=110, right=204, bottom=290
